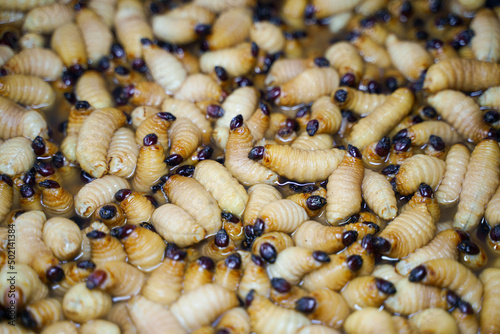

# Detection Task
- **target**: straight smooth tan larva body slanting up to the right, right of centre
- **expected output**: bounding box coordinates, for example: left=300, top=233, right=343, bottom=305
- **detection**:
left=347, top=88, right=414, bottom=149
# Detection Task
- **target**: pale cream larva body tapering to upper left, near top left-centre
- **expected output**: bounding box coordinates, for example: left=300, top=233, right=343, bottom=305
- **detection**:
left=142, top=42, right=187, bottom=93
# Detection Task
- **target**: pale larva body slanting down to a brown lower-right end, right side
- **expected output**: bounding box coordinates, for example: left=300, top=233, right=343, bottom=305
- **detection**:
left=427, top=90, right=490, bottom=143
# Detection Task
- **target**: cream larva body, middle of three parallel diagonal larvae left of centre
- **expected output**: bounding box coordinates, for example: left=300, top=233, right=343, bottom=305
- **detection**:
left=163, top=175, right=222, bottom=236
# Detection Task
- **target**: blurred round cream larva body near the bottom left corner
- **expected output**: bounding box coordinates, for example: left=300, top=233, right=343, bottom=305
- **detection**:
left=63, top=283, right=112, bottom=323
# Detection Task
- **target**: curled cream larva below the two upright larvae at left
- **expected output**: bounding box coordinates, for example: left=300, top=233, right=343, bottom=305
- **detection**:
left=75, top=175, right=130, bottom=217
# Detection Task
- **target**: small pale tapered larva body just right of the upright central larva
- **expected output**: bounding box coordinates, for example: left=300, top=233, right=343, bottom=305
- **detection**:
left=361, top=169, right=398, bottom=220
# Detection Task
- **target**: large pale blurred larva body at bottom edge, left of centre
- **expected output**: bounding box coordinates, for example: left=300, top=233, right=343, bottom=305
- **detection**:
left=170, top=284, right=238, bottom=330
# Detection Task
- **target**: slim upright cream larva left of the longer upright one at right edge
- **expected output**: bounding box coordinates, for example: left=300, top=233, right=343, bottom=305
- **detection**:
left=436, top=144, right=470, bottom=207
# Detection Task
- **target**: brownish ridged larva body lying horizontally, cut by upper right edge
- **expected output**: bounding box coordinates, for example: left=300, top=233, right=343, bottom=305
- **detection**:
left=424, top=58, right=500, bottom=93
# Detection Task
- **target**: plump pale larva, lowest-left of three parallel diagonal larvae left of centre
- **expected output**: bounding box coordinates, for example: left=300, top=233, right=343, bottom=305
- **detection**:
left=151, top=204, right=206, bottom=247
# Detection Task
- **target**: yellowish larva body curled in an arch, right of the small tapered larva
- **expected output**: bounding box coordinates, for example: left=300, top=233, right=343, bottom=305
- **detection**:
left=396, top=154, right=446, bottom=195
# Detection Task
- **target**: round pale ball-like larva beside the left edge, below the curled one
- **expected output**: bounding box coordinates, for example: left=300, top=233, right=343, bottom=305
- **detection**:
left=42, top=218, right=82, bottom=261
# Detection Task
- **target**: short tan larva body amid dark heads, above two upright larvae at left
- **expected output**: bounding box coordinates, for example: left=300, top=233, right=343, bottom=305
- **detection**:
left=75, top=71, right=114, bottom=109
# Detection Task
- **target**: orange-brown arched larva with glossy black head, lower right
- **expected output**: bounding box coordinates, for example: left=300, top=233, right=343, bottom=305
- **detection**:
left=408, top=259, right=483, bottom=312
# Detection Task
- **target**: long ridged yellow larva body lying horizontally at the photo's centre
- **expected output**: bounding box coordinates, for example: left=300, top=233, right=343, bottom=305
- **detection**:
left=262, top=144, right=345, bottom=182
